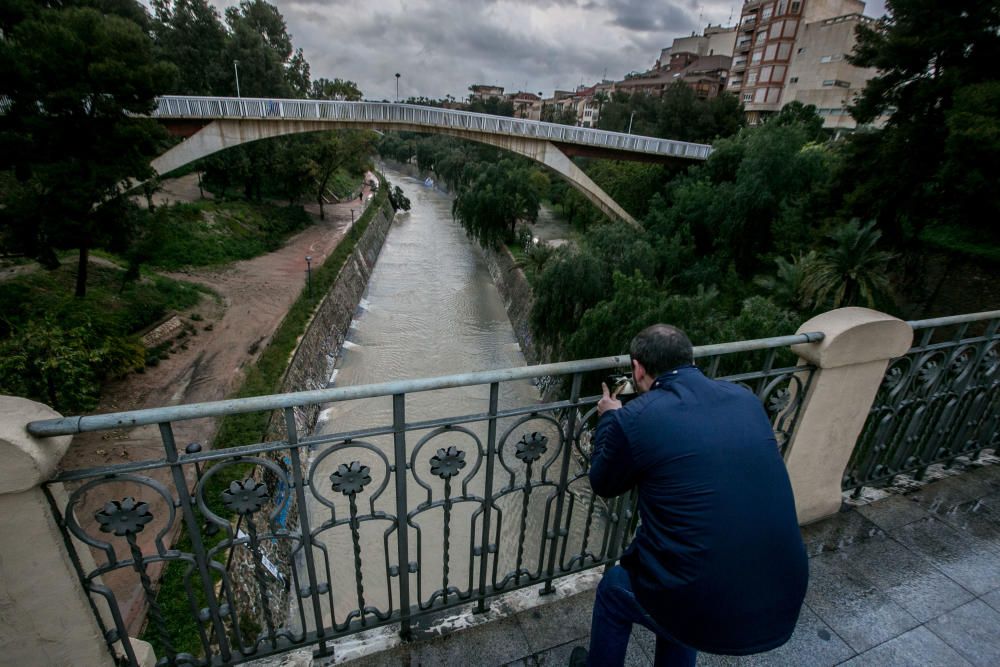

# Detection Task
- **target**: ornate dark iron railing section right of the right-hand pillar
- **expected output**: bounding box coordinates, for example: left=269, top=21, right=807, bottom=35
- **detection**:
left=843, top=311, right=1000, bottom=497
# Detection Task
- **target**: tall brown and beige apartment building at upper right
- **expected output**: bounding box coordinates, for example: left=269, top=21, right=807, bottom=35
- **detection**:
left=728, top=0, right=872, bottom=129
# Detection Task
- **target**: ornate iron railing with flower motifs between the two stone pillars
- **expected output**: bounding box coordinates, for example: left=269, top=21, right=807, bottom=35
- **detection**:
left=35, top=333, right=822, bottom=665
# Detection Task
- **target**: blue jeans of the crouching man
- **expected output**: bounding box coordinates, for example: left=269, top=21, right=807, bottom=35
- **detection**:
left=588, top=565, right=698, bottom=667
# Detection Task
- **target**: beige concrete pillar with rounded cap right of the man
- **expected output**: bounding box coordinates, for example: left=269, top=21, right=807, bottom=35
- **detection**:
left=786, top=308, right=913, bottom=524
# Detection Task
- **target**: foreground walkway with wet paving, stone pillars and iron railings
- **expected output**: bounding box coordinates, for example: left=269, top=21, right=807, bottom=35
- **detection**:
left=0, top=310, right=1000, bottom=665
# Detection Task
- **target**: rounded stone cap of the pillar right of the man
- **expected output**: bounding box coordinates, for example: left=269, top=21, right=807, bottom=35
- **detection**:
left=792, top=307, right=913, bottom=368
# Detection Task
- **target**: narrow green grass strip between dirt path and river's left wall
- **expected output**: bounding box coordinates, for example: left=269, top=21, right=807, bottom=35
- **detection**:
left=143, top=183, right=387, bottom=656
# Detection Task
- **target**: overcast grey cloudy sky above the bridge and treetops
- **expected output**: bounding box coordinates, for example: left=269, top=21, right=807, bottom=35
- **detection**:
left=212, top=0, right=884, bottom=100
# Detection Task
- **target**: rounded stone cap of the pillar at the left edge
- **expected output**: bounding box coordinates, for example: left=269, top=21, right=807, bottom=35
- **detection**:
left=0, top=395, right=73, bottom=494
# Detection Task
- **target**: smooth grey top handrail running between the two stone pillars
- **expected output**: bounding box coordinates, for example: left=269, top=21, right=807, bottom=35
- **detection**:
left=27, top=332, right=823, bottom=438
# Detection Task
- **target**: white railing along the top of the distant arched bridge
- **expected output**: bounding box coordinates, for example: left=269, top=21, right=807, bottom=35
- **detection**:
left=152, top=96, right=712, bottom=160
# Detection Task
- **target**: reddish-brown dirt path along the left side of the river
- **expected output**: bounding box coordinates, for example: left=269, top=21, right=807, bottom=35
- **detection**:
left=61, top=175, right=376, bottom=636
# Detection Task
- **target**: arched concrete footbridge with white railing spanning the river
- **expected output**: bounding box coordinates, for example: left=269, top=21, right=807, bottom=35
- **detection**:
left=150, top=96, right=712, bottom=224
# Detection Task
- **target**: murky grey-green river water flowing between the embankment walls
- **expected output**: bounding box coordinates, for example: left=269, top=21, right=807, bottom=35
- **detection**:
left=300, top=171, right=584, bottom=623
